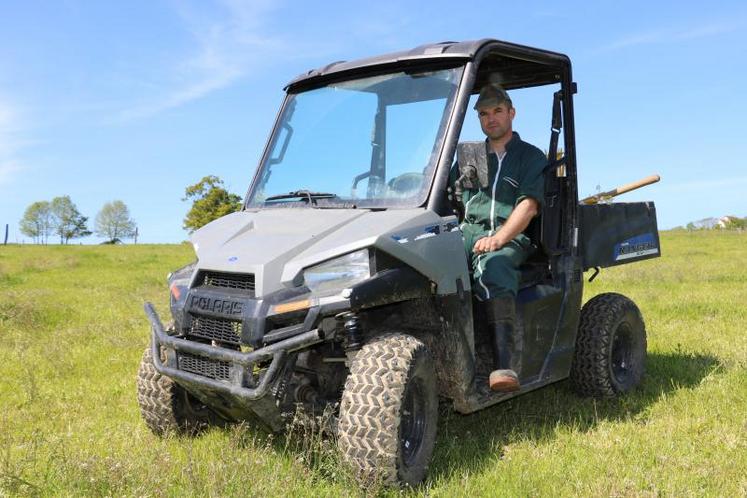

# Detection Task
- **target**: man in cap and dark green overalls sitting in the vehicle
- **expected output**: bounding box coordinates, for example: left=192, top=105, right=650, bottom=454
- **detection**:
left=452, top=84, right=547, bottom=392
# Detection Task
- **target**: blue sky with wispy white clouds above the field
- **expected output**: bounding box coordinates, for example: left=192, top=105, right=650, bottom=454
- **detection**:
left=0, top=0, right=747, bottom=243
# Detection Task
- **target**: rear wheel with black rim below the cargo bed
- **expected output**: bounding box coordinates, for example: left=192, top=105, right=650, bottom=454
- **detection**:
left=571, top=293, right=646, bottom=397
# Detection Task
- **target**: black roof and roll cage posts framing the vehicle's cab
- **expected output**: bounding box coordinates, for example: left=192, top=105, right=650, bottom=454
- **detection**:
left=250, top=39, right=578, bottom=274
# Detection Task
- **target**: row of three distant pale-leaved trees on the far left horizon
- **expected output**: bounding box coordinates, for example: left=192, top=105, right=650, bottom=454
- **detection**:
left=19, top=195, right=137, bottom=244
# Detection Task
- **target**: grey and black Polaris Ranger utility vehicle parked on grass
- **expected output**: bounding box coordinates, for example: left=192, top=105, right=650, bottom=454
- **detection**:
left=137, top=40, right=659, bottom=485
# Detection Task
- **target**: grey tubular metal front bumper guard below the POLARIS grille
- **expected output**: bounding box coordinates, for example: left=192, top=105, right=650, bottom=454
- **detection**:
left=145, top=303, right=325, bottom=401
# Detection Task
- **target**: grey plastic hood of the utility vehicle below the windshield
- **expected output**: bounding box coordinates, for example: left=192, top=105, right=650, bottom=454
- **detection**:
left=192, top=208, right=432, bottom=296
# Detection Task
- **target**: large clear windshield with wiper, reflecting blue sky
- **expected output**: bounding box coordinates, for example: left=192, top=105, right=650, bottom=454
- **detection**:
left=247, top=68, right=462, bottom=208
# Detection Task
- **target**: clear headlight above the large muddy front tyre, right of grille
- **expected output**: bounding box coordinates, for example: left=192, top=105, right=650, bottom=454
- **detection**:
left=303, top=249, right=371, bottom=295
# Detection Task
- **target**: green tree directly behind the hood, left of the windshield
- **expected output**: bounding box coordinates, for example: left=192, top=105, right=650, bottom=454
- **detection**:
left=182, top=175, right=241, bottom=233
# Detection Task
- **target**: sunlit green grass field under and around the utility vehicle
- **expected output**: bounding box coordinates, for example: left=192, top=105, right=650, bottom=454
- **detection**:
left=0, top=232, right=747, bottom=496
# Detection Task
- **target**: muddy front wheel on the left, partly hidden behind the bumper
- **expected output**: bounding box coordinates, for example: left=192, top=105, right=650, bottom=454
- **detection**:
left=137, top=347, right=222, bottom=436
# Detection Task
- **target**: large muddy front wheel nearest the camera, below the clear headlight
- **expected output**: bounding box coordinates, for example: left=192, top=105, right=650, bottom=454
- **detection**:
left=338, top=334, right=438, bottom=486
